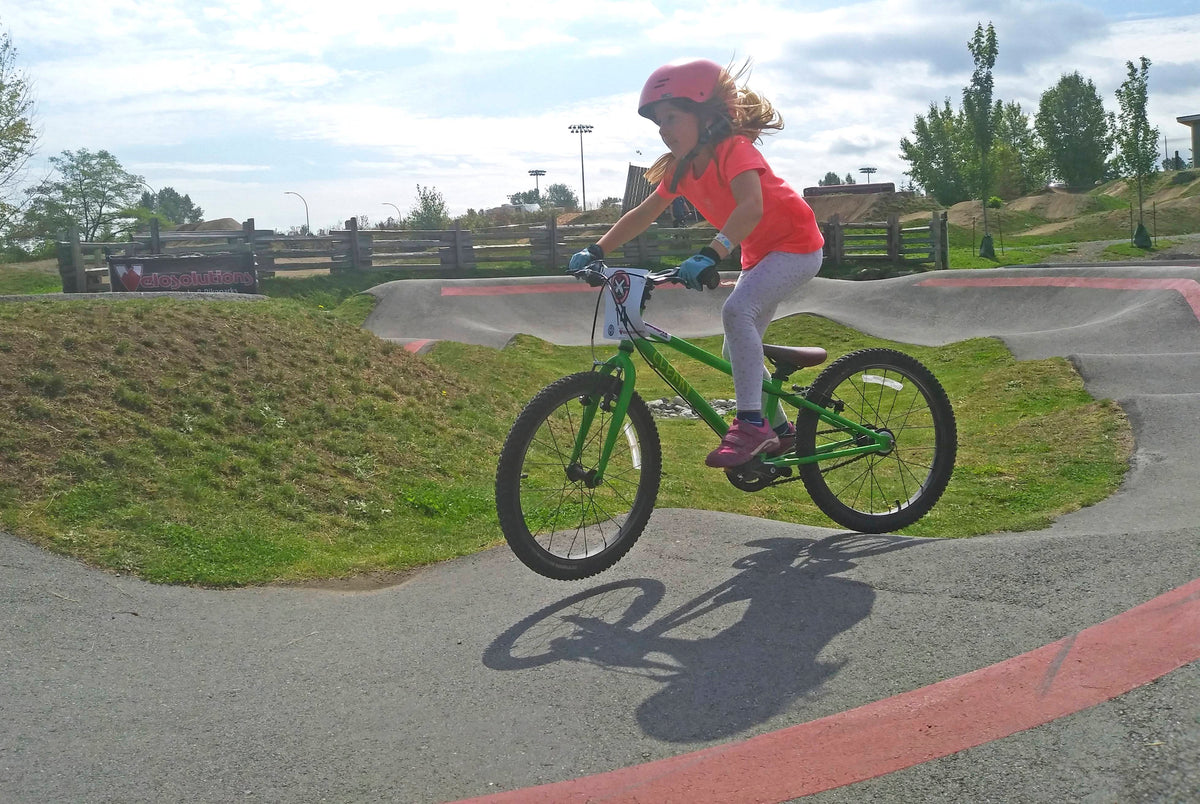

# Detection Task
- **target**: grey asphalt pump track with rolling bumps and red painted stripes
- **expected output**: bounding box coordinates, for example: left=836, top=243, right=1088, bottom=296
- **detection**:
left=0, top=264, right=1200, bottom=802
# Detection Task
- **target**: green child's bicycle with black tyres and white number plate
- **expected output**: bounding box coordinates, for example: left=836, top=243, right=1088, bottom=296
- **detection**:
left=496, top=262, right=958, bottom=581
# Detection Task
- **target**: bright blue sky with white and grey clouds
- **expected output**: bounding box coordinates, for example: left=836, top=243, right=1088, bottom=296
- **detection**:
left=0, top=0, right=1200, bottom=230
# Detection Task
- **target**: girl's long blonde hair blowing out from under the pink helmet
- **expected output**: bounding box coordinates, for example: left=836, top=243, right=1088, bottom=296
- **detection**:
left=646, top=59, right=784, bottom=184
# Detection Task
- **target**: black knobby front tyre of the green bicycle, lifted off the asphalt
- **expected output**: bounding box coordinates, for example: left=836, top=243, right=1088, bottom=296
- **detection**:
left=496, top=372, right=662, bottom=581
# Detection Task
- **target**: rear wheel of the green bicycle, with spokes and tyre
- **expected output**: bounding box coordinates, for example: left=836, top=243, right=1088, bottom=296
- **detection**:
left=796, top=349, right=958, bottom=533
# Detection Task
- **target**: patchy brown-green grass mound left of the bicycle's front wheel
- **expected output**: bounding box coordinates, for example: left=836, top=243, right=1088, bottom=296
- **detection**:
left=0, top=299, right=496, bottom=586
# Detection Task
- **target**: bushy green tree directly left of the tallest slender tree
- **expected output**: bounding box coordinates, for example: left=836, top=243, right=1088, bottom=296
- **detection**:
left=900, top=98, right=973, bottom=206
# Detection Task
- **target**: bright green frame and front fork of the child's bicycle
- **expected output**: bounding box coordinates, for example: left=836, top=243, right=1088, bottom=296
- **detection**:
left=571, top=328, right=892, bottom=485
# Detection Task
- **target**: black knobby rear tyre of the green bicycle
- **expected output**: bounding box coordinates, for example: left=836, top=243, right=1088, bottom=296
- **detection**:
left=796, top=348, right=958, bottom=533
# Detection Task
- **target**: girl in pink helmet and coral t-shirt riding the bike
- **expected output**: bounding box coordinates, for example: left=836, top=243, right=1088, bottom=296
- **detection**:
left=570, top=60, right=824, bottom=468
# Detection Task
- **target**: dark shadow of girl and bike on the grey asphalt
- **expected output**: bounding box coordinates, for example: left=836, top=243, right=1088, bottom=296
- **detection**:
left=482, top=534, right=931, bottom=743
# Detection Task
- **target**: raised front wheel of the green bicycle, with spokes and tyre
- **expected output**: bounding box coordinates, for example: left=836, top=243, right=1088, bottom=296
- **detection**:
left=496, top=372, right=662, bottom=581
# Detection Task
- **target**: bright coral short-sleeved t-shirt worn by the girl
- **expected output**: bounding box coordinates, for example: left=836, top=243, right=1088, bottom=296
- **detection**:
left=654, top=137, right=824, bottom=270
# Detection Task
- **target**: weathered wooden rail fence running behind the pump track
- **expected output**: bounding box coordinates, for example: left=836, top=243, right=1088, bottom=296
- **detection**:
left=59, top=212, right=948, bottom=293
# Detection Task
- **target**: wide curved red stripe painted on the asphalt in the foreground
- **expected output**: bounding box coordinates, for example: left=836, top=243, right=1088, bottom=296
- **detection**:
left=456, top=578, right=1200, bottom=804
